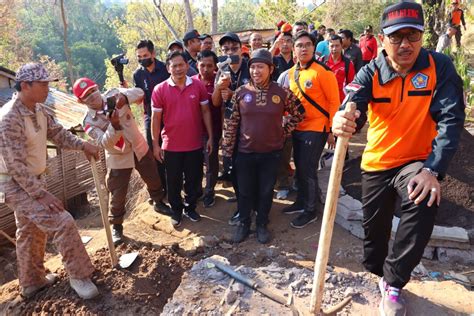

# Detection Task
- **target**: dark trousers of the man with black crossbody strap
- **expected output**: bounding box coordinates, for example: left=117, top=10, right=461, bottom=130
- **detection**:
left=293, top=131, right=328, bottom=213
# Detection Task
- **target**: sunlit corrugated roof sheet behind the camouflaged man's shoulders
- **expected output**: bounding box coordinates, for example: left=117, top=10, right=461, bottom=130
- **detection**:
left=0, top=88, right=87, bottom=131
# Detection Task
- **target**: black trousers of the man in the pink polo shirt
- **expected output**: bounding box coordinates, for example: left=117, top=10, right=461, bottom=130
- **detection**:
left=164, top=148, right=203, bottom=216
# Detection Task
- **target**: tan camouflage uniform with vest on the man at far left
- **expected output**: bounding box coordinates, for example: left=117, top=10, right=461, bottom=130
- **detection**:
left=0, top=97, right=94, bottom=288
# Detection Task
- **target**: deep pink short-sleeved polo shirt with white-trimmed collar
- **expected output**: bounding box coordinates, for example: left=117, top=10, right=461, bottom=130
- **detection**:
left=151, top=77, right=209, bottom=152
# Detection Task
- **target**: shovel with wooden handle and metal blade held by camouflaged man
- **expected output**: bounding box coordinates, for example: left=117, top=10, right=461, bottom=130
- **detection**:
left=91, top=157, right=138, bottom=269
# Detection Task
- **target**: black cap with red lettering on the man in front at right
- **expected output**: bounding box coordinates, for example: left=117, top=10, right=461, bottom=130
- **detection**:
left=380, top=1, right=424, bottom=35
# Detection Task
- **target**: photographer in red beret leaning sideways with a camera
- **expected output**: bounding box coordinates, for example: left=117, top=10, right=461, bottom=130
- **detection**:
left=73, top=78, right=164, bottom=244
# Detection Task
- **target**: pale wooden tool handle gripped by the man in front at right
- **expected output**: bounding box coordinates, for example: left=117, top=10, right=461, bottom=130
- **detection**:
left=310, top=102, right=356, bottom=314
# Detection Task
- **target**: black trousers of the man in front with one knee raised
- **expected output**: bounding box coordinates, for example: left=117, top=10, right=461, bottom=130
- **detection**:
left=362, top=161, right=438, bottom=288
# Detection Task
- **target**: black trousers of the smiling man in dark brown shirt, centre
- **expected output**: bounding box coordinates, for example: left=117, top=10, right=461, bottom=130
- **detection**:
left=235, top=150, right=281, bottom=226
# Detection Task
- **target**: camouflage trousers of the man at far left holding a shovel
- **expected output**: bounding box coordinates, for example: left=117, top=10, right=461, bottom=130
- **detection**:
left=0, top=180, right=94, bottom=287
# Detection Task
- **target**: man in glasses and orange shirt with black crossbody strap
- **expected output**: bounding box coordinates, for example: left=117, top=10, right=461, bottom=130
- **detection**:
left=283, top=31, right=340, bottom=228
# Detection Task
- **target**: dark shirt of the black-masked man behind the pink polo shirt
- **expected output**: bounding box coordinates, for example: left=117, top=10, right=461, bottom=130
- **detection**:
left=133, top=59, right=170, bottom=120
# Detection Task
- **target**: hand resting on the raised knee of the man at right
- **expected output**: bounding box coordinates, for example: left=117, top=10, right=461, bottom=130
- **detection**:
left=407, top=170, right=441, bottom=207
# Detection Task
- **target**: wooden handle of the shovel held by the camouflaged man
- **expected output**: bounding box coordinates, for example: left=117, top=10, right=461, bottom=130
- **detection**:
left=91, top=157, right=118, bottom=267
